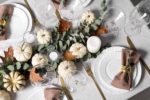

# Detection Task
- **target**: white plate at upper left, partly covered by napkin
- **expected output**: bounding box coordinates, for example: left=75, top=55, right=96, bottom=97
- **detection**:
left=0, top=3, right=32, bottom=55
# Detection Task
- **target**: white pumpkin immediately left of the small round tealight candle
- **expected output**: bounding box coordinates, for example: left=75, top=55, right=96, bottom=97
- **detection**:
left=32, top=53, right=48, bottom=67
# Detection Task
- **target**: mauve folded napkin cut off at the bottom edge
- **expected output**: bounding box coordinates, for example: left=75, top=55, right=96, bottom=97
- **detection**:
left=44, top=88, right=62, bottom=100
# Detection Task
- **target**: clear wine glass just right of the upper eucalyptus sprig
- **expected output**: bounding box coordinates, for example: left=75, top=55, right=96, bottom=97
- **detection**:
left=102, top=6, right=126, bottom=36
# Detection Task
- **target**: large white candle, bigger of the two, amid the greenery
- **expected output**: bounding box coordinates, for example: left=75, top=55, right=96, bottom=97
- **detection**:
left=87, top=36, right=101, bottom=53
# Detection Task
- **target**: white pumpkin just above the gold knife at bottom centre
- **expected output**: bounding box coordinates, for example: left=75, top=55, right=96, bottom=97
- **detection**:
left=58, top=61, right=77, bottom=78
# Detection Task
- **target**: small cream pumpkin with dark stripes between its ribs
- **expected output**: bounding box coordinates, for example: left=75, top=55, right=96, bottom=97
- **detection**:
left=3, top=71, right=26, bottom=92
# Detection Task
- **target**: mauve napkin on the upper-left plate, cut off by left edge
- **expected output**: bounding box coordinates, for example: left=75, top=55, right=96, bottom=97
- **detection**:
left=0, top=5, right=13, bottom=40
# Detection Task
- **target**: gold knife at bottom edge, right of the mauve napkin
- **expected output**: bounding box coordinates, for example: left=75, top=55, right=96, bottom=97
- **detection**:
left=60, top=77, right=73, bottom=100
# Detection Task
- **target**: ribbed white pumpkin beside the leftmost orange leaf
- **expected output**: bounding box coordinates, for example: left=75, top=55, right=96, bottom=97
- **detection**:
left=14, top=43, right=32, bottom=62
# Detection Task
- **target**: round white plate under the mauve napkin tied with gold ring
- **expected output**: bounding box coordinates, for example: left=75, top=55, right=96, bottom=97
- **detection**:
left=93, top=47, right=142, bottom=93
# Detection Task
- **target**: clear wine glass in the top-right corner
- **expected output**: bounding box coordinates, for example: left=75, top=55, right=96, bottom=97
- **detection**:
left=125, top=0, right=150, bottom=36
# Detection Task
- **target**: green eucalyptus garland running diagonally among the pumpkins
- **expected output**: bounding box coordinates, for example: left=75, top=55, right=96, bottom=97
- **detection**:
left=0, top=0, right=107, bottom=92
